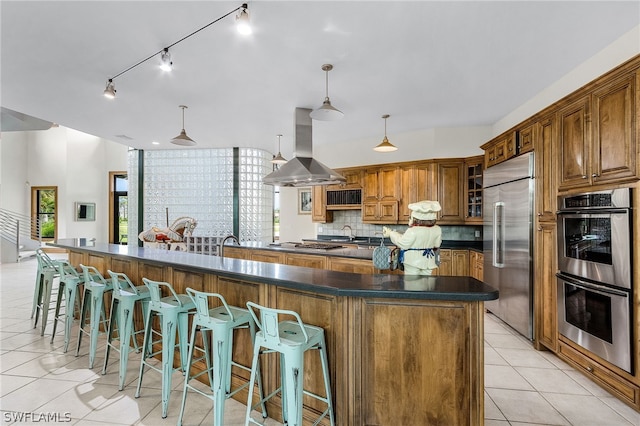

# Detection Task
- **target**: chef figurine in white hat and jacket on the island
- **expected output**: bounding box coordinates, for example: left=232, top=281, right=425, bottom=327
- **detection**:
left=382, top=201, right=442, bottom=275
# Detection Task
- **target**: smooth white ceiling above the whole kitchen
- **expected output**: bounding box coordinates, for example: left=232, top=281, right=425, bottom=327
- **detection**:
left=0, top=1, right=640, bottom=152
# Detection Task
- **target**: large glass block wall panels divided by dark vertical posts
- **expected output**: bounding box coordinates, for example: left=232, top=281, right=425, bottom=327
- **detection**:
left=129, top=148, right=273, bottom=242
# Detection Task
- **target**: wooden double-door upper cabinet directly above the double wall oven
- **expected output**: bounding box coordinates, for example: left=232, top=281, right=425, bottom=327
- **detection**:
left=558, top=73, right=640, bottom=190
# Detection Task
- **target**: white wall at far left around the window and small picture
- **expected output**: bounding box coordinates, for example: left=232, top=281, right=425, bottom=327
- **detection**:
left=0, top=127, right=128, bottom=241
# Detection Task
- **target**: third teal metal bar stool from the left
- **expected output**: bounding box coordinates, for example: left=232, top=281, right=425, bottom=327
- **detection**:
left=76, top=264, right=113, bottom=368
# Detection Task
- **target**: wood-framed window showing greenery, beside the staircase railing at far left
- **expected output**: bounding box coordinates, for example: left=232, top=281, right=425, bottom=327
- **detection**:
left=31, top=186, right=58, bottom=240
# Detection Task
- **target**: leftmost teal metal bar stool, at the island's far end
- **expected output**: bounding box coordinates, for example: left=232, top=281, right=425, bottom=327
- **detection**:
left=31, top=249, right=60, bottom=336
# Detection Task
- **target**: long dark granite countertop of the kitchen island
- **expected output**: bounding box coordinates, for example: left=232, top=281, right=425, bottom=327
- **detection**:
left=48, top=238, right=498, bottom=301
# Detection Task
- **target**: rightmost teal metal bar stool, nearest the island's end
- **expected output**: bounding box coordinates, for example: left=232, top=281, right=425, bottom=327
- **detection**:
left=245, top=302, right=335, bottom=426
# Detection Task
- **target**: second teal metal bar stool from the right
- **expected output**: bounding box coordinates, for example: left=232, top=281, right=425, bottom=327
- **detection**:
left=177, top=288, right=267, bottom=426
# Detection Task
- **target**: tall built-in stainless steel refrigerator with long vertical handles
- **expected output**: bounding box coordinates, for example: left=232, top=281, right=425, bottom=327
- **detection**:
left=482, top=152, right=534, bottom=340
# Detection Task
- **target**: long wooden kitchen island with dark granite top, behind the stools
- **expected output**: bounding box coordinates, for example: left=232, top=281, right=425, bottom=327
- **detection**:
left=51, top=239, right=498, bottom=426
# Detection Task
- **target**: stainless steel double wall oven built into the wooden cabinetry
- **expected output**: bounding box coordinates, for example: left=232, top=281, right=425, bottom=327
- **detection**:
left=557, top=188, right=637, bottom=373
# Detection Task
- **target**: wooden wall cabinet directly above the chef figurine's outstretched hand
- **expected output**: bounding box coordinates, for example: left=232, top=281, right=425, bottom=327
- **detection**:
left=362, top=167, right=400, bottom=223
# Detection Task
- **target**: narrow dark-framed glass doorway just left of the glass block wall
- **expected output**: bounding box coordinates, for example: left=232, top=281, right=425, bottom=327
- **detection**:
left=109, top=172, right=129, bottom=245
